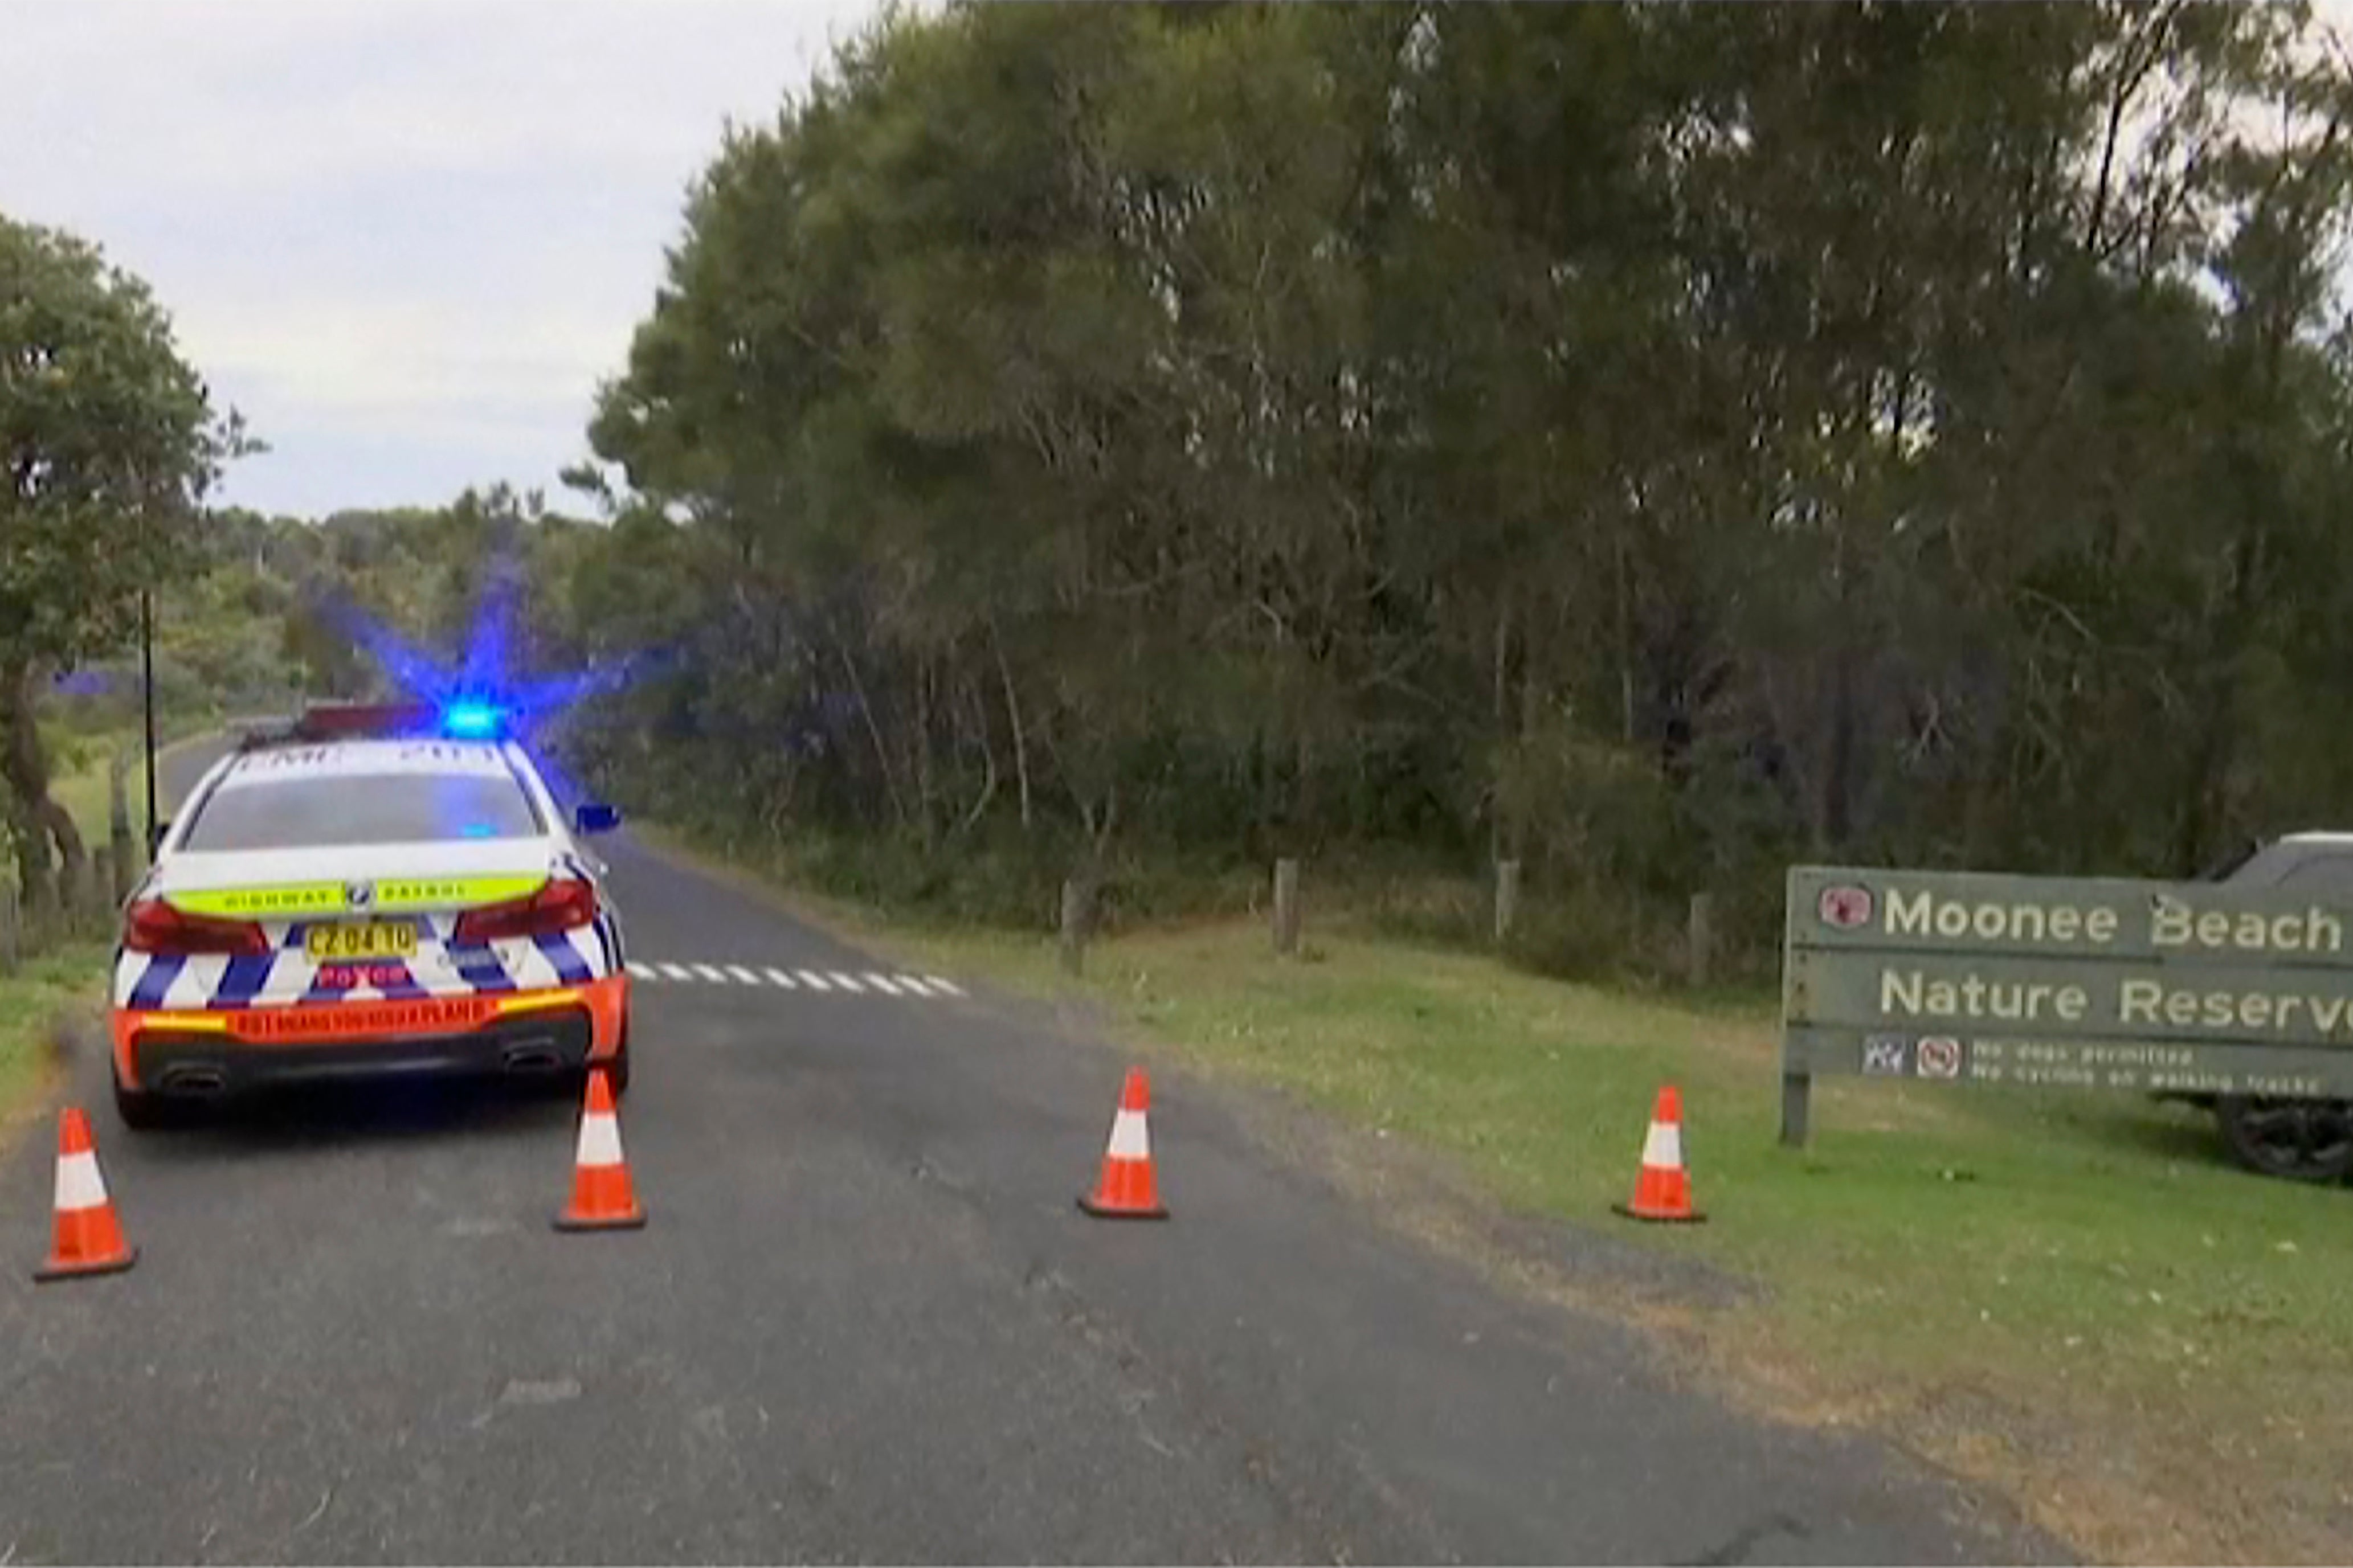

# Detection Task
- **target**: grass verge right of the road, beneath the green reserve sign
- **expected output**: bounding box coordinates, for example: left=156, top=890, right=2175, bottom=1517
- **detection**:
left=701, top=860, right=2353, bottom=1561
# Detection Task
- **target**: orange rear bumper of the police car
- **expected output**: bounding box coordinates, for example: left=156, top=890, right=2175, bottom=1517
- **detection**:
left=113, top=976, right=628, bottom=1095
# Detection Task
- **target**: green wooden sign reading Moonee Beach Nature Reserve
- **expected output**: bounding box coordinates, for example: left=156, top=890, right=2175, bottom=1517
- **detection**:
left=1781, top=865, right=2353, bottom=1145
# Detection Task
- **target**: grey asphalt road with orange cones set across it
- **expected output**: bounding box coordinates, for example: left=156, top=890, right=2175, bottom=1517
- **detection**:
left=0, top=755, right=2054, bottom=1563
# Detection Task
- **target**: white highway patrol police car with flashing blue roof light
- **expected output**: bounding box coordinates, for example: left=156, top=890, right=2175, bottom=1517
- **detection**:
left=113, top=703, right=628, bottom=1128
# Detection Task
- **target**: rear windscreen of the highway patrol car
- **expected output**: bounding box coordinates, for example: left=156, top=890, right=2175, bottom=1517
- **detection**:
left=181, top=773, right=541, bottom=853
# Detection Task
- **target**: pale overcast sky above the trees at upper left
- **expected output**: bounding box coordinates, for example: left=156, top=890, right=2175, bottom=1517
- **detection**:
left=0, top=0, right=877, bottom=515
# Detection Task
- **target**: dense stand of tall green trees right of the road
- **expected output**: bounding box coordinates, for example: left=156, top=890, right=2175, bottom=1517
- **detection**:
left=538, top=2, right=2353, bottom=968
